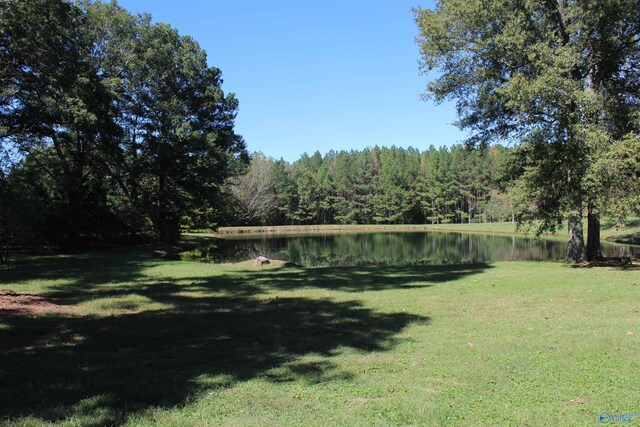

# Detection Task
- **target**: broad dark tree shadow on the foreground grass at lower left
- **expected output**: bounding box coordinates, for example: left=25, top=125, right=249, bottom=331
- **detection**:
left=0, top=290, right=429, bottom=425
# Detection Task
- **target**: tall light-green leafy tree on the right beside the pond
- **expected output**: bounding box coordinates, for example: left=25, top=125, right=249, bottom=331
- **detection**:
left=415, top=0, right=640, bottom=261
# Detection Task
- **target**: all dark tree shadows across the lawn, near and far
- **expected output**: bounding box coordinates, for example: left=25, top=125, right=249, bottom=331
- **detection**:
left=0, top=253, right=496, bottom=425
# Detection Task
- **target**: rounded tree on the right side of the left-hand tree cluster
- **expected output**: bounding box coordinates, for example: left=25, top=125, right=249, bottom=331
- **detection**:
left=86, top=2, right=244, bottom=241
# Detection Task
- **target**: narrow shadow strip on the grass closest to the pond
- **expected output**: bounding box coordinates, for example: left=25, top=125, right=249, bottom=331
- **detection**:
left=33, top=263, right=492, bottom=305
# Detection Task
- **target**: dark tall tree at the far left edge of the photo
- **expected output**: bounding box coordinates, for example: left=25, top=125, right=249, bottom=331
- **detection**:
left=0, top=0, right=117, bottom=244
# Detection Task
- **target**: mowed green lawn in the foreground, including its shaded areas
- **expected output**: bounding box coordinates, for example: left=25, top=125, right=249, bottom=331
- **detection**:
left=0, top=248, right=640, bottom=426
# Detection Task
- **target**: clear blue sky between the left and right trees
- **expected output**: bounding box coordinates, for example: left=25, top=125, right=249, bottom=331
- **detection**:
left=119, top=0, right=465, bottom=161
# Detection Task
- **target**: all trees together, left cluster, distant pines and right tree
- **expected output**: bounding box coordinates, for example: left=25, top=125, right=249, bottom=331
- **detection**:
left=0, top=0, right=640, bottom=261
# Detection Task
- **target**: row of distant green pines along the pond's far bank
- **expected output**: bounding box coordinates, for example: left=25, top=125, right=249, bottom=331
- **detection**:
left=224, top=145, right=516, bottom=225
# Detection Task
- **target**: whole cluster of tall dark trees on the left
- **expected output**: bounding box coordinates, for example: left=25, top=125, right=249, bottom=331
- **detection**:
left=0, top=0, right=246, bottom=254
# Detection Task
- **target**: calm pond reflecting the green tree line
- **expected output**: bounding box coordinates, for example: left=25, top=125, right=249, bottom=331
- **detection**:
left=183, top=231, right=640, bottom=267
